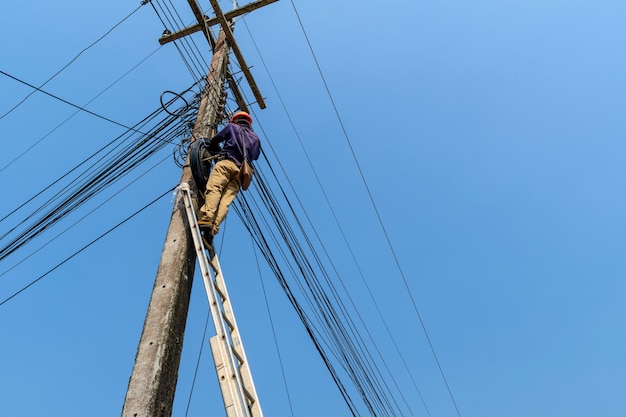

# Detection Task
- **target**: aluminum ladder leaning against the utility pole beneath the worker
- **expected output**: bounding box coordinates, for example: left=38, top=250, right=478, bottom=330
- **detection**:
left=178, top=183, right=263, bottom=417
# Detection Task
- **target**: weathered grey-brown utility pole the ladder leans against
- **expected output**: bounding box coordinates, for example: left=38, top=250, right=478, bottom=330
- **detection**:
left=122, top=31, right=229, bottom=417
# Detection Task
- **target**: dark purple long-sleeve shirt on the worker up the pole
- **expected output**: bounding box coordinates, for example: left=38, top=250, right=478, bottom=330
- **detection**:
left=210, top=123, right=261, bottom=167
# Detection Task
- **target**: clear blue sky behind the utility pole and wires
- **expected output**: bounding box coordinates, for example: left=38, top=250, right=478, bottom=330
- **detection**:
left=0, top=0, right=626, bottom=417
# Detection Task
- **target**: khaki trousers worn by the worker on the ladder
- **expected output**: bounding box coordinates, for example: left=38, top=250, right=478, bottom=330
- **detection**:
left=198, top=159, right=239, bottom=235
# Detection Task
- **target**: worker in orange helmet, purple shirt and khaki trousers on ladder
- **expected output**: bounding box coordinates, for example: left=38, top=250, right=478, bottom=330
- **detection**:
left=198, top=111, right=261, bottom=246
